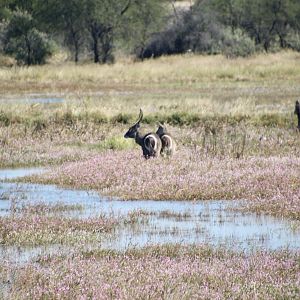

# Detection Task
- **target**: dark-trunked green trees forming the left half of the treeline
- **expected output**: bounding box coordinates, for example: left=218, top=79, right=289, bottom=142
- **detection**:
left=0, top=0, right=167, bottom=65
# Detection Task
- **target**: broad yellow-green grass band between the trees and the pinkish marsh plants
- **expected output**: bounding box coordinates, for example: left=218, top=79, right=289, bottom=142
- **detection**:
left=0, top=52, right=300, bottom=127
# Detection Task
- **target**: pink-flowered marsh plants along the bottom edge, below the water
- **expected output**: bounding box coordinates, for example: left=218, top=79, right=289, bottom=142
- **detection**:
left=0, top=245, right=299, bottom=299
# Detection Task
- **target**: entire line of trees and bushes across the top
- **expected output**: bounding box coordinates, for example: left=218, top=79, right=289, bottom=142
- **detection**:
left=0, top=0, right=300, bottom=65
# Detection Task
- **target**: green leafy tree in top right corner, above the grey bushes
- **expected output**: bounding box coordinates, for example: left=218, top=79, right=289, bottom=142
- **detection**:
left=210, top=0, right=300, bottom=51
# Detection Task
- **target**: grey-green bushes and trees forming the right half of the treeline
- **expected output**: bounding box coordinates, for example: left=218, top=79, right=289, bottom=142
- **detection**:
left=140, top=0, right=300, bottom=58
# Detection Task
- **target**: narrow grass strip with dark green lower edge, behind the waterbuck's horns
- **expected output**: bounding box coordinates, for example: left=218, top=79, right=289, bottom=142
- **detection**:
left=0, top=97, right=297, bottom=131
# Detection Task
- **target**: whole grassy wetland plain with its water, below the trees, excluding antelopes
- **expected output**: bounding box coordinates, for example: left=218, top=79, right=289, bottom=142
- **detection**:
left=0, top=52, right=300, bottom=299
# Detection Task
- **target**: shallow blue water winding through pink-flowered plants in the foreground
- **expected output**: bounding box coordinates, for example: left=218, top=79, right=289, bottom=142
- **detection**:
left=0, top=169, right=300, bottom=261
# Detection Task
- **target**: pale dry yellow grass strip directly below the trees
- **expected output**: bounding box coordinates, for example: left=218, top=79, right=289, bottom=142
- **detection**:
left=0, top=52, right=300, bottom=87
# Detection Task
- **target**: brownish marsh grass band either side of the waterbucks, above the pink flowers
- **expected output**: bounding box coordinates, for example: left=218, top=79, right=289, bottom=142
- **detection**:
left=0, top=109, right=300, bottom=168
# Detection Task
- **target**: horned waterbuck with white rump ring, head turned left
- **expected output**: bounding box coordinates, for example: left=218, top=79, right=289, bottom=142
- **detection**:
left=124, top=109, right=162, bottom=159
